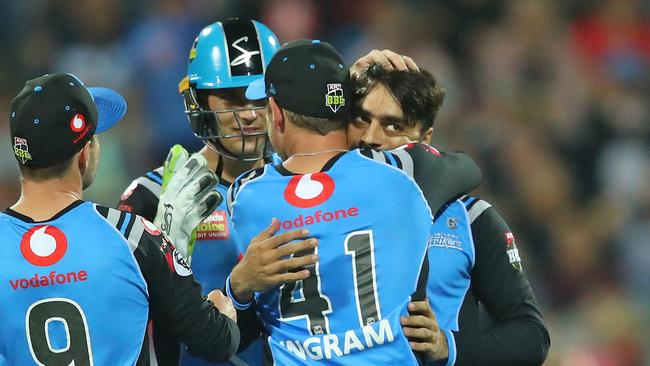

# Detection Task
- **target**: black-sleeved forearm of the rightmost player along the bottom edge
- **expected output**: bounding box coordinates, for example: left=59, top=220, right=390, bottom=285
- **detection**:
left=454, top=319, right=550, bottom=366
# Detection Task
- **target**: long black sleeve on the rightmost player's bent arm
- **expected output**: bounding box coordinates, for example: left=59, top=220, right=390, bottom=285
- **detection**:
left=454, top=208, right=550, bottom=366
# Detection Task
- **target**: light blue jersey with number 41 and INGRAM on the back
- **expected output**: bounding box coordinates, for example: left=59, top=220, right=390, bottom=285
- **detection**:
left=231, top=150, right=432, bottom=365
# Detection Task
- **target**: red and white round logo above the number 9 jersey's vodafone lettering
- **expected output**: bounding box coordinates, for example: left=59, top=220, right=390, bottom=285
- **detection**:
left=20, top=225, right=68, bottom=267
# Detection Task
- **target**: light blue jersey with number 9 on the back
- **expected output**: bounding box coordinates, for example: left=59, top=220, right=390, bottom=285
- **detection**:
left=0, top=201, right=149, bottom=366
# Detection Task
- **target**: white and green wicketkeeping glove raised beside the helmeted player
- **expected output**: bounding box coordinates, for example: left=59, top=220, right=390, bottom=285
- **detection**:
left=154, top=145, right=223, bottom=262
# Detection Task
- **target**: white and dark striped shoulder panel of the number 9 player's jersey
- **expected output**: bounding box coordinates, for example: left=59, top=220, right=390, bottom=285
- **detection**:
left=95, top=204, right=154, bottom=251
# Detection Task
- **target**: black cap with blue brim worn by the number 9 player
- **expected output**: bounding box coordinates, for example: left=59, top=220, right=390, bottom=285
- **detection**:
left=9, top=74, right=127, bottom=167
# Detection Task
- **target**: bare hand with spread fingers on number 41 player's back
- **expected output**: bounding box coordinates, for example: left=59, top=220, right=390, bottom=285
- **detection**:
left=230, top=219, right=318, bottom=302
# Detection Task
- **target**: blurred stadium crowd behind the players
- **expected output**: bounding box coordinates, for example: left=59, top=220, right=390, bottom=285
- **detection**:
left=0, top=0, right=650, bottom=366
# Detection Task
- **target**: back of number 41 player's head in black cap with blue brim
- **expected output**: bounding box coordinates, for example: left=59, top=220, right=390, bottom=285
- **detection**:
left=246, top=40, right=352, bottom=135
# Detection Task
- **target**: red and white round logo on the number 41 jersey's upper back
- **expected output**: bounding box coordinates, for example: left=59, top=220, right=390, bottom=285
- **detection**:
left=284, top=172, right=334, bottom=208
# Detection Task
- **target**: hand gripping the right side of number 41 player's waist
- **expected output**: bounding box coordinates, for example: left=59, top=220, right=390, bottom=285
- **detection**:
left=400, top=301, right=449, bottom=361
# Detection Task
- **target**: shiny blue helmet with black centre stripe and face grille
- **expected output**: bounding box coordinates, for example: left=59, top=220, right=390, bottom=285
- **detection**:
left=179, top=19, right=281, bottom=160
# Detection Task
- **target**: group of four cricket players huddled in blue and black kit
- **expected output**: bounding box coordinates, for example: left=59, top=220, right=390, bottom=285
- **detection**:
left=0, top=19, right=550, bottom=365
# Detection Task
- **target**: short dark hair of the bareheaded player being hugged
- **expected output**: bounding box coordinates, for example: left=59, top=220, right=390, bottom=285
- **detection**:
left=354, top=64, right=446, bottom=131
